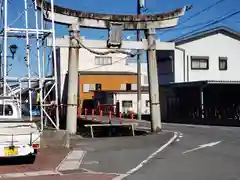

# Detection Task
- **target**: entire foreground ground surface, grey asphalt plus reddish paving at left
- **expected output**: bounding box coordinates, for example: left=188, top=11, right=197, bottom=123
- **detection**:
left=0, top=118, right=240, bottom=180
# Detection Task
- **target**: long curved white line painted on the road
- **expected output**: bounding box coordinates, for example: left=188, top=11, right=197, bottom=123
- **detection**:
left=112, top=132, right=178, bottom=180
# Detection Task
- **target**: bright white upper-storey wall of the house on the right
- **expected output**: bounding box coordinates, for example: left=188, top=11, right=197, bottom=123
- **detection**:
left=175, top=33, right=240, bottom=82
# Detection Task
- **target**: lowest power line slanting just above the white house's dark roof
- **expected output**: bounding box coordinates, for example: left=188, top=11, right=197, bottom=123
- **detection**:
left=171, top=10, right=240, bottom=41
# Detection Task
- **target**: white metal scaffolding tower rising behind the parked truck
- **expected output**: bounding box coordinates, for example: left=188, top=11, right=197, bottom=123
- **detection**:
left=0, top=0, right=59, bottom=129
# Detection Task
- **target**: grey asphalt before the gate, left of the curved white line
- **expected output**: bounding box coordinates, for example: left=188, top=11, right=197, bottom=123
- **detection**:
left=75, top=132, right=173, bottom=174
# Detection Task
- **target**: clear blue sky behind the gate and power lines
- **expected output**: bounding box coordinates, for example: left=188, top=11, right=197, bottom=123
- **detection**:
left=0, top=0, right=240, bottom=76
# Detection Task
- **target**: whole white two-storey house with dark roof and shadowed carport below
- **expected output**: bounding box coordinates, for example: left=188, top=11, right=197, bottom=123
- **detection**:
left=157, top=26, right=240, bottom=126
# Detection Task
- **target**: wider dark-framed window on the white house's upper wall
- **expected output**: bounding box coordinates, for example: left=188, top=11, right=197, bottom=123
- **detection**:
left=191, top=56, right=209, bottom=70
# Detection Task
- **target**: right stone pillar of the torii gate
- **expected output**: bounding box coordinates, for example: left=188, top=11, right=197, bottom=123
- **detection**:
left=145, top=28, right=162, bottom=132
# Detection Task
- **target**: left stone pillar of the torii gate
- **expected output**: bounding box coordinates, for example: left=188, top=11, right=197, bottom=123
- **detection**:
left=67, top=24, right=80, bottom=134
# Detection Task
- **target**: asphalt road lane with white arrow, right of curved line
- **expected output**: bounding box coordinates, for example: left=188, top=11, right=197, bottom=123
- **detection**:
left=124, top=125, right=240, bottom=180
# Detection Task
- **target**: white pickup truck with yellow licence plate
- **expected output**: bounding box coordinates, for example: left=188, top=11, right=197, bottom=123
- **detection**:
left=0, top=96, right=41, bottom=160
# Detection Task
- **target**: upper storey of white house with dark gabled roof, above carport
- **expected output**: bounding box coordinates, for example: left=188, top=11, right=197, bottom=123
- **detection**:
left=158, top=26, right=240, bottom=84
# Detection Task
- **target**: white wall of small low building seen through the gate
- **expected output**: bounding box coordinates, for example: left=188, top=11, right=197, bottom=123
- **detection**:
left=114, top=93, right=150, bottom=114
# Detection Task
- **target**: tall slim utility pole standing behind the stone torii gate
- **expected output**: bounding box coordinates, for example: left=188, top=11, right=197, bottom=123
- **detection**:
left=137, top=0, right=142, bottom=121
